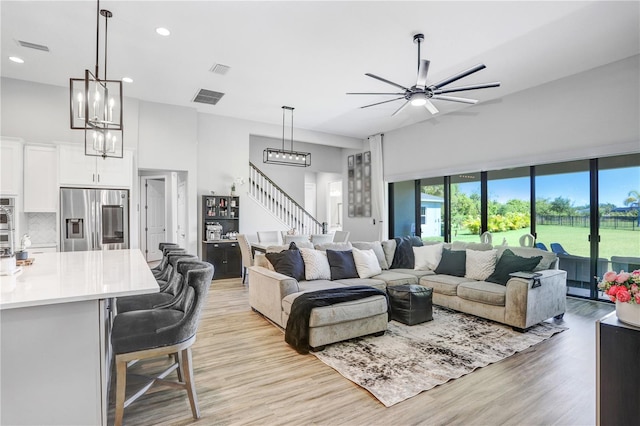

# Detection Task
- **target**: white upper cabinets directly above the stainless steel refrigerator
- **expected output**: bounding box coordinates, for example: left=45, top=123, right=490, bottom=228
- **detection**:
left=58, top=145, right=133, bottom=188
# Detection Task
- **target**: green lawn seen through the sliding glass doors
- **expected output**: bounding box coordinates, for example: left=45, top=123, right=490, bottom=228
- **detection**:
left=452, top=225, right=640, bottom=259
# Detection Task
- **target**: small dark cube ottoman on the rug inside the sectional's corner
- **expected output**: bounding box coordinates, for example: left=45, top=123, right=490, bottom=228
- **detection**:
left=387, top=284, right=433, bottom=325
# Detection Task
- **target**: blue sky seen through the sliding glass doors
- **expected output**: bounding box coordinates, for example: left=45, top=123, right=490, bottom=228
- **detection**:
left=460, top=166, right=640, bottom=207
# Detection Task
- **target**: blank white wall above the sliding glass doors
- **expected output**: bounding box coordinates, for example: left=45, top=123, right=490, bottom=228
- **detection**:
left=383, top=55, right=640, bottom=182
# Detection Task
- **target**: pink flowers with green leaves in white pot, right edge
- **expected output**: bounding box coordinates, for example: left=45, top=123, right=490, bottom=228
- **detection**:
left=598, top=269, right=640, bottom=327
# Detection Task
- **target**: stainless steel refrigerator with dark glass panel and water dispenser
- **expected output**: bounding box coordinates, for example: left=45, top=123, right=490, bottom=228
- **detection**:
left=60, top=188, right=129, bottom=251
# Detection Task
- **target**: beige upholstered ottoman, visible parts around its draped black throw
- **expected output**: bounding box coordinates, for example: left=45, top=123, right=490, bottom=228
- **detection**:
left=282, top=293, right=389, bottom=351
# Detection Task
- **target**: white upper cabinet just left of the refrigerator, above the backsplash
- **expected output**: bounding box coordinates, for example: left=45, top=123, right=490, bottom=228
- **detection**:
left=24, top=145, right=58, bottom=213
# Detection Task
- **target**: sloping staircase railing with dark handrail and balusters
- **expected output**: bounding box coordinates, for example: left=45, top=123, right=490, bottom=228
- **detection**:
left=249, top=162, right=322, bottom=234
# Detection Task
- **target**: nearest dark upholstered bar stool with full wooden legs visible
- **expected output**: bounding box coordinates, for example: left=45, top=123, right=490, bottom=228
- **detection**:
left=111, top=261, right=213, bottom=426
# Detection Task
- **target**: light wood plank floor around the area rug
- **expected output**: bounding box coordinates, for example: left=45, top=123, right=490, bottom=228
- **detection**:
left=111, top=279, right=614, bottom=426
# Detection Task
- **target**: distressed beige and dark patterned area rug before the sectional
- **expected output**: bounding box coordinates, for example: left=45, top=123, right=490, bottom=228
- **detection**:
left=313, top=306, right=567, bottom=407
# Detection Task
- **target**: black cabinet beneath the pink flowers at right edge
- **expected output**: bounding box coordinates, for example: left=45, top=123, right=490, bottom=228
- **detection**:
left=596, top=312, right=640, bottom=426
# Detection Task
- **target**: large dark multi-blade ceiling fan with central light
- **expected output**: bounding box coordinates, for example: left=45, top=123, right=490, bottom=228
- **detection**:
left=347, top=34, right=500, bottom=116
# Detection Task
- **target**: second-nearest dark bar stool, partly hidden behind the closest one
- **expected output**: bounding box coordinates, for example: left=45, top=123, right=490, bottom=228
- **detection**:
left=116, top=254, right=198, bottom=314
